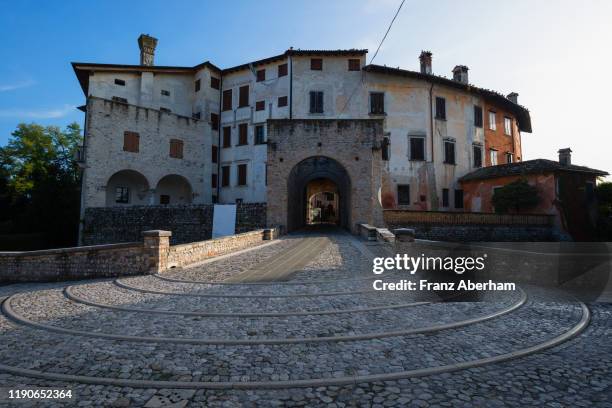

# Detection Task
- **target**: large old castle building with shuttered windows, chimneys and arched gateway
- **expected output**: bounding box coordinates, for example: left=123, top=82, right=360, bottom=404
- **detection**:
left=72, top=35, right=531, bottom=236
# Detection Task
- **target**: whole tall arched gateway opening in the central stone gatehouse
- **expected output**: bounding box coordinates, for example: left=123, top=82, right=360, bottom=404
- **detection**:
left=287, top=156, right=351, bottom=231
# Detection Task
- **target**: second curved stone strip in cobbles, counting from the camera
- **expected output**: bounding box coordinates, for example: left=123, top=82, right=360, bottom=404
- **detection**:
left=2, top=288, right=527, bottom=346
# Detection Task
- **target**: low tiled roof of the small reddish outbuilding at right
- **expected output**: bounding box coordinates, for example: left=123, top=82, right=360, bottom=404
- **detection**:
left=459, top=159, right=608, bottom=181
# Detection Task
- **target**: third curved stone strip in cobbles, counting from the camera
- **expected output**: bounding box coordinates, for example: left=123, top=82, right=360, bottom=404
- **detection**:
left=64, top=286, right=436, bottom=317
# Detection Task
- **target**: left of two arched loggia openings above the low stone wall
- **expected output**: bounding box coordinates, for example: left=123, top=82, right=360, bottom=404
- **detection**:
left=106, top=169, right=150, bottom=207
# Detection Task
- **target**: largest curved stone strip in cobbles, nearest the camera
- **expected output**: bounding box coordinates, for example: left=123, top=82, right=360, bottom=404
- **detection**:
left=0, top=301, right=591, bottom=389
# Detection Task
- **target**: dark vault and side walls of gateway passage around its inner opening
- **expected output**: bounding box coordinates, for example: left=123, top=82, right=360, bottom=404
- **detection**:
left=287, top=156, right=351, bottom=231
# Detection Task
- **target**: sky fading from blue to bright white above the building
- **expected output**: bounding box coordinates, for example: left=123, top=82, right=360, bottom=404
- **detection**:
left=0, top=0, right=612, bottom=177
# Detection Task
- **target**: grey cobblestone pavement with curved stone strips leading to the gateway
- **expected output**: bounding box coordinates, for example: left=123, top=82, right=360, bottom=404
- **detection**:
left=0, top=228, right=612, bottom=407
